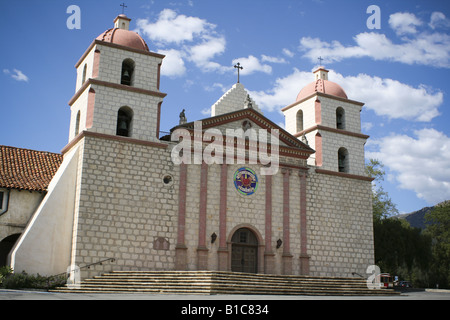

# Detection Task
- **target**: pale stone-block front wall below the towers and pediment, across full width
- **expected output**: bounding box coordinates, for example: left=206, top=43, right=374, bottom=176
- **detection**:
left=70, top=131, right=373, bottom=276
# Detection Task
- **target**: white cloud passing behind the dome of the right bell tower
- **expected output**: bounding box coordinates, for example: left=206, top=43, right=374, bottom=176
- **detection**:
left=251, top=69, right=444, bottom=122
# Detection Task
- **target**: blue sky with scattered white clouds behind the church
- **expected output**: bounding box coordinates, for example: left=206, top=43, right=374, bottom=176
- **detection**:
left=0, top=0, right=450, bottom=213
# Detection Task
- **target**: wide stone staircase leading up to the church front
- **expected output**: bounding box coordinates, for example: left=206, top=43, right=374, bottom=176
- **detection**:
left=52, top=271, right=398, bottom=296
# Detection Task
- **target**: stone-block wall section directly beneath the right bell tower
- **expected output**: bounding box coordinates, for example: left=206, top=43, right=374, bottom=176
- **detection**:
left=307, top=170, right=374, bottom=276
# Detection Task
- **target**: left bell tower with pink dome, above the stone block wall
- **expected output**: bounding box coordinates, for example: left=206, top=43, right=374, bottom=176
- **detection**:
left=69, top=14, right=166, bottom=142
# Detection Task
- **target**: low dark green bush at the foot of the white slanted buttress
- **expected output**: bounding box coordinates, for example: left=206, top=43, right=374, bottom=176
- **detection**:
left=2, top=272, right=66, bottom=290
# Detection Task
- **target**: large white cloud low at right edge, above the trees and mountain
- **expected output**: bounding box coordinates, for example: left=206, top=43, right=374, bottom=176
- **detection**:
left=366, top=129, right=450, bottom=204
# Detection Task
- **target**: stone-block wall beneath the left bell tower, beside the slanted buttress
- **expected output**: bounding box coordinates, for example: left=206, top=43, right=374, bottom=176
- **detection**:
left=73, top=136, right=179, bottom=274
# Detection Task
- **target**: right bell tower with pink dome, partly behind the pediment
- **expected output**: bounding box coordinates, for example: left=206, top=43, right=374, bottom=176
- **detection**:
left=282, top=67, right=369, bottom=176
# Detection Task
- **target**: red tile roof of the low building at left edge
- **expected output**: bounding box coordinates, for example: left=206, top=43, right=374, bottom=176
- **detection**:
left=0, top=146, right=63, bottom=191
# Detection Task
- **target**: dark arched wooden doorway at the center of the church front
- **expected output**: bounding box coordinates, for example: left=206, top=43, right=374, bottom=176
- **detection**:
left=231, top=228, right=258, bottom=273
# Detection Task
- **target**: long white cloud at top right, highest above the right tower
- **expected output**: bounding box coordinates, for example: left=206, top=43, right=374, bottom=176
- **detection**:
left=299, top=13, right=450, bottom=68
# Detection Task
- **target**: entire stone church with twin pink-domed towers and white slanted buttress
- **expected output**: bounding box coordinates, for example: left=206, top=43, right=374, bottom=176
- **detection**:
left=9, top=15, right=374, bottom=278
